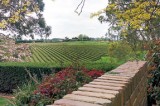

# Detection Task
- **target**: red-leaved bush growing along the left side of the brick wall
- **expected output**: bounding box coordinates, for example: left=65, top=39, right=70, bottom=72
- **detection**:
left=12, top=67, right=104, bottom=106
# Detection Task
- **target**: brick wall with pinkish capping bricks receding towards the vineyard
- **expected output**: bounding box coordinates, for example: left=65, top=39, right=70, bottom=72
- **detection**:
left=51, top=61, right=147, bottom=106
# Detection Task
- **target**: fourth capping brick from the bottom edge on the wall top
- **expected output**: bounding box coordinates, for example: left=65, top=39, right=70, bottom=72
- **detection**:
left=78, top=87, right=119, bottom=95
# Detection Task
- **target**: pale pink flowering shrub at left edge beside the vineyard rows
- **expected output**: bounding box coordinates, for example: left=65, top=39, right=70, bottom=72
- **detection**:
left=0, top=35, right=31, bottom=62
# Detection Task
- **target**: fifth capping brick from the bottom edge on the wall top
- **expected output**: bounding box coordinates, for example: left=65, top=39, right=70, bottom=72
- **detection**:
left=84, top=84, right=122, bottom=91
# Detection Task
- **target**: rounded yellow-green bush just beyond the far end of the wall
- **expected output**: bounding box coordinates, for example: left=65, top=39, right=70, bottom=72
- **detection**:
left=107, top=41, right=146, bottom=62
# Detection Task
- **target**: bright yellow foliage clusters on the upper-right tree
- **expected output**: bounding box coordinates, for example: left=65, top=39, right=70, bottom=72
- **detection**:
left=98, top=0, right=160, bottom=29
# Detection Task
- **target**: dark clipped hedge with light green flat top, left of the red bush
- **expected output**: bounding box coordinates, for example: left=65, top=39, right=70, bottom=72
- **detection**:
left=0, top=63, right=61, bottom=93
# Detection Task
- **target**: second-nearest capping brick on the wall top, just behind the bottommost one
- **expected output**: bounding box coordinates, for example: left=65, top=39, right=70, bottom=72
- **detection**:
left=63, top=94, right=111, bottom=106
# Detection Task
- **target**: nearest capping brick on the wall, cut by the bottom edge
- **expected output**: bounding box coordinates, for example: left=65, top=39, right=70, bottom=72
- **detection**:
left=54, top=99, right=102, bottom=106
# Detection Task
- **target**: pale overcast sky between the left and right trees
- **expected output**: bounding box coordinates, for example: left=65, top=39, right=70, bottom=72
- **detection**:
left=44, top=0, right=108, bottom=38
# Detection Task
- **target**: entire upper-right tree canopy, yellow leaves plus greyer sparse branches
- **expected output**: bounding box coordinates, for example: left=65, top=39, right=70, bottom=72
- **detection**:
left=92, top=0, right=160, bottom=41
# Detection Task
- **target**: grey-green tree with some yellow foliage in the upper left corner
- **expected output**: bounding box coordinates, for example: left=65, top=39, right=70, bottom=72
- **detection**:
left=0, top=0, right=49, bottom=38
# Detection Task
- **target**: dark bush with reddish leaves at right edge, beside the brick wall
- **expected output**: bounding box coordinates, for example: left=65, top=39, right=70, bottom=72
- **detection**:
left=147, top=41, right=160, bottom=106
